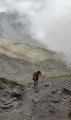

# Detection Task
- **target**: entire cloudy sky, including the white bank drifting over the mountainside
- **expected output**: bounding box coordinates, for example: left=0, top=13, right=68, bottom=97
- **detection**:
left=0, top=0, right=71, bottom=63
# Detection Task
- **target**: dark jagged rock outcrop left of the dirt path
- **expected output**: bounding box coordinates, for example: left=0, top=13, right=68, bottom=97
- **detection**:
left=0, top=77, right=24, bottom=110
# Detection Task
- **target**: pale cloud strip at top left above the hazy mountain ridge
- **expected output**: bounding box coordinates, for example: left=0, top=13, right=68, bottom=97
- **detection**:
left=0, top=0, right=42, bottom=13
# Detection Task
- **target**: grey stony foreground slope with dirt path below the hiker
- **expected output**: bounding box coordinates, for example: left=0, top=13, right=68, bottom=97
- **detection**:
left=0, top=78, right=71, bottom=120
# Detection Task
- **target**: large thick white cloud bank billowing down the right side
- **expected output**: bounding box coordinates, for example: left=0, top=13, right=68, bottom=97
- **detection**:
left=25, top=0, right=71, bottom=64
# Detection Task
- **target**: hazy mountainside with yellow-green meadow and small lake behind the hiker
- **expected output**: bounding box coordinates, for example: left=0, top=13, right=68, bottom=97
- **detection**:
left=0, top=11, right=71, bottom=82
